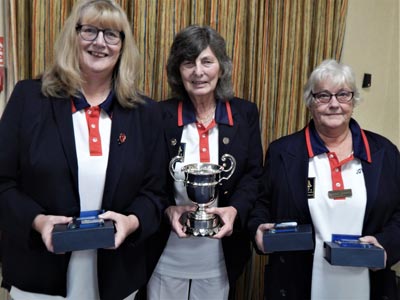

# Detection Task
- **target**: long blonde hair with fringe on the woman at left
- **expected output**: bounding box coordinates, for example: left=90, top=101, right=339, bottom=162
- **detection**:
left=42, top=0, right=142, bottom=108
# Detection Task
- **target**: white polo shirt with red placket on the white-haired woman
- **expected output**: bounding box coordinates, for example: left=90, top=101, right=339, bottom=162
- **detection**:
left=306, top=121, right=371, bottom=300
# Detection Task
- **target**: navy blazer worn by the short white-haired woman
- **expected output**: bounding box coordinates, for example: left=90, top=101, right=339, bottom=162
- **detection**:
left=249, top=125, right=400, bottom=300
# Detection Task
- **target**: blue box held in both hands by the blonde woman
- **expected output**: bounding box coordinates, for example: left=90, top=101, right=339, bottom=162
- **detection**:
left=52, top=211, right=115, bottom=253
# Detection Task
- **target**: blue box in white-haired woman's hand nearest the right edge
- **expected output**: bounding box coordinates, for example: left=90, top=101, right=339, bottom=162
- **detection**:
left=324, top=234, right=385, bottom=269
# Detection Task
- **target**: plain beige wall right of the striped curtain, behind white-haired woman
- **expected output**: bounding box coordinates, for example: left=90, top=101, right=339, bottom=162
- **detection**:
left=341, top=0, right=400, bottom=147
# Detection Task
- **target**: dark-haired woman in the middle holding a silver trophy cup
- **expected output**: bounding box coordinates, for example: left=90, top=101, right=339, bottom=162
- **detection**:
left=147, top=25, right=263, bottom=299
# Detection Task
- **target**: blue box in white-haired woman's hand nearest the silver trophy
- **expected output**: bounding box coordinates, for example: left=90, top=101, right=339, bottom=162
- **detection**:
left=263, top=224, right=314, bottom=253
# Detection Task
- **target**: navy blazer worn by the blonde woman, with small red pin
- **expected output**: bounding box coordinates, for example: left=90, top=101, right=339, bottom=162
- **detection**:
left=0, top=80, right=168, bottom=300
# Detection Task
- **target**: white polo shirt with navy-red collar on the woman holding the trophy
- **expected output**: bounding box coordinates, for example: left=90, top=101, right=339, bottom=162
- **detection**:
left=154, top=101, right=233, bottom=279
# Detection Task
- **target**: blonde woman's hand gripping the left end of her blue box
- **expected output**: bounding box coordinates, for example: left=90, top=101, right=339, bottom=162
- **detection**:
left=32, top=214, right=72, bottom=253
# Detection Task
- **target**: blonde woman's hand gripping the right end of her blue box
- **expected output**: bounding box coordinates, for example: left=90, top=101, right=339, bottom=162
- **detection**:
left=99, top=211, right=140, bottom=249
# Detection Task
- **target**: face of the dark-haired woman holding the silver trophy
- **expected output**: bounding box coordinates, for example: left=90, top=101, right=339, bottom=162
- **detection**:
left=179, top=47, right=220, bottom=99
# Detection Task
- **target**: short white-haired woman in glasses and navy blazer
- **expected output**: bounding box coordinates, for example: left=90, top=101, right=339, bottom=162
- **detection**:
left=249, top=60, right=400, bottom=299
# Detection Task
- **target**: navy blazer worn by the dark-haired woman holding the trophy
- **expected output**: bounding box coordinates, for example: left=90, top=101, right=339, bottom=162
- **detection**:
left=145, top=98, right=263, bottom=287
